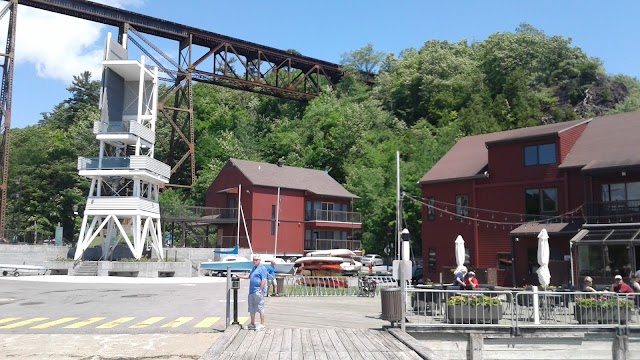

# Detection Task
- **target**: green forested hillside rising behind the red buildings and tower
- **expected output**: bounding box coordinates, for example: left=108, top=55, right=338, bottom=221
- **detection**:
left=7, top=24, right=640, bottom=252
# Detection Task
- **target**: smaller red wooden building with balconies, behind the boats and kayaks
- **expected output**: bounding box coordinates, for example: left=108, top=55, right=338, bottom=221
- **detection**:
left=205, top=159, right=362, bottom=256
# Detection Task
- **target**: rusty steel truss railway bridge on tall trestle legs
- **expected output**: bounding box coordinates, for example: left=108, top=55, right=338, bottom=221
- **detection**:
left=0, top=0, right=358, bottom=238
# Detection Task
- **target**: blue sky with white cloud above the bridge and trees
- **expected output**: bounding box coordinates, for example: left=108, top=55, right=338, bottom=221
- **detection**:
left=0, top=0, right=640, bottom=128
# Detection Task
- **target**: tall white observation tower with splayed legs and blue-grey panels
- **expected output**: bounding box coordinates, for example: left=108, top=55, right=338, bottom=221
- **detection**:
left=74, top=34, right=171, bottom=260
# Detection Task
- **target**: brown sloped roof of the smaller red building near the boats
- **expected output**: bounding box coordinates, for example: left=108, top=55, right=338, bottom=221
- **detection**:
left=229, top=159, right=359, bottom=199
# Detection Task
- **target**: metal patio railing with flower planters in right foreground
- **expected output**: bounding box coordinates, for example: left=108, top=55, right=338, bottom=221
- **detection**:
left=406, top=288, right=640, bottom=330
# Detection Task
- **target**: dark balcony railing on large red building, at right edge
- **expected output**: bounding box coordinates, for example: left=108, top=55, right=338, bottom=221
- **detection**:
left=584, top=200, right=640, bottom=223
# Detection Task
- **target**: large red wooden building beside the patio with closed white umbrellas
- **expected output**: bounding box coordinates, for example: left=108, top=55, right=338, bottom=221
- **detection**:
left=419, top=112, right=640, bottom=286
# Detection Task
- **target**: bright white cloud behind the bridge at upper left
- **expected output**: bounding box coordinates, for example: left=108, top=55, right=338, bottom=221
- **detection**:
left=0, top=0, right=143, bottom=84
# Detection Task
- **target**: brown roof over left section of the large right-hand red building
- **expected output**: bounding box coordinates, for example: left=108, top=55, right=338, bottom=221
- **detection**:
left=419, top=120, right=589, bottom=183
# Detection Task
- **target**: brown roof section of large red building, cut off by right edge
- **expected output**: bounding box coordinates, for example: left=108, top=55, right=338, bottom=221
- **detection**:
left=559, top=112, right=640, bottom=170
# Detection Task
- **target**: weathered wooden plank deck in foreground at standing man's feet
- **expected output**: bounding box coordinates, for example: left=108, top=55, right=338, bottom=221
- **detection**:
left=219, top=328, right=421, bottom=360
